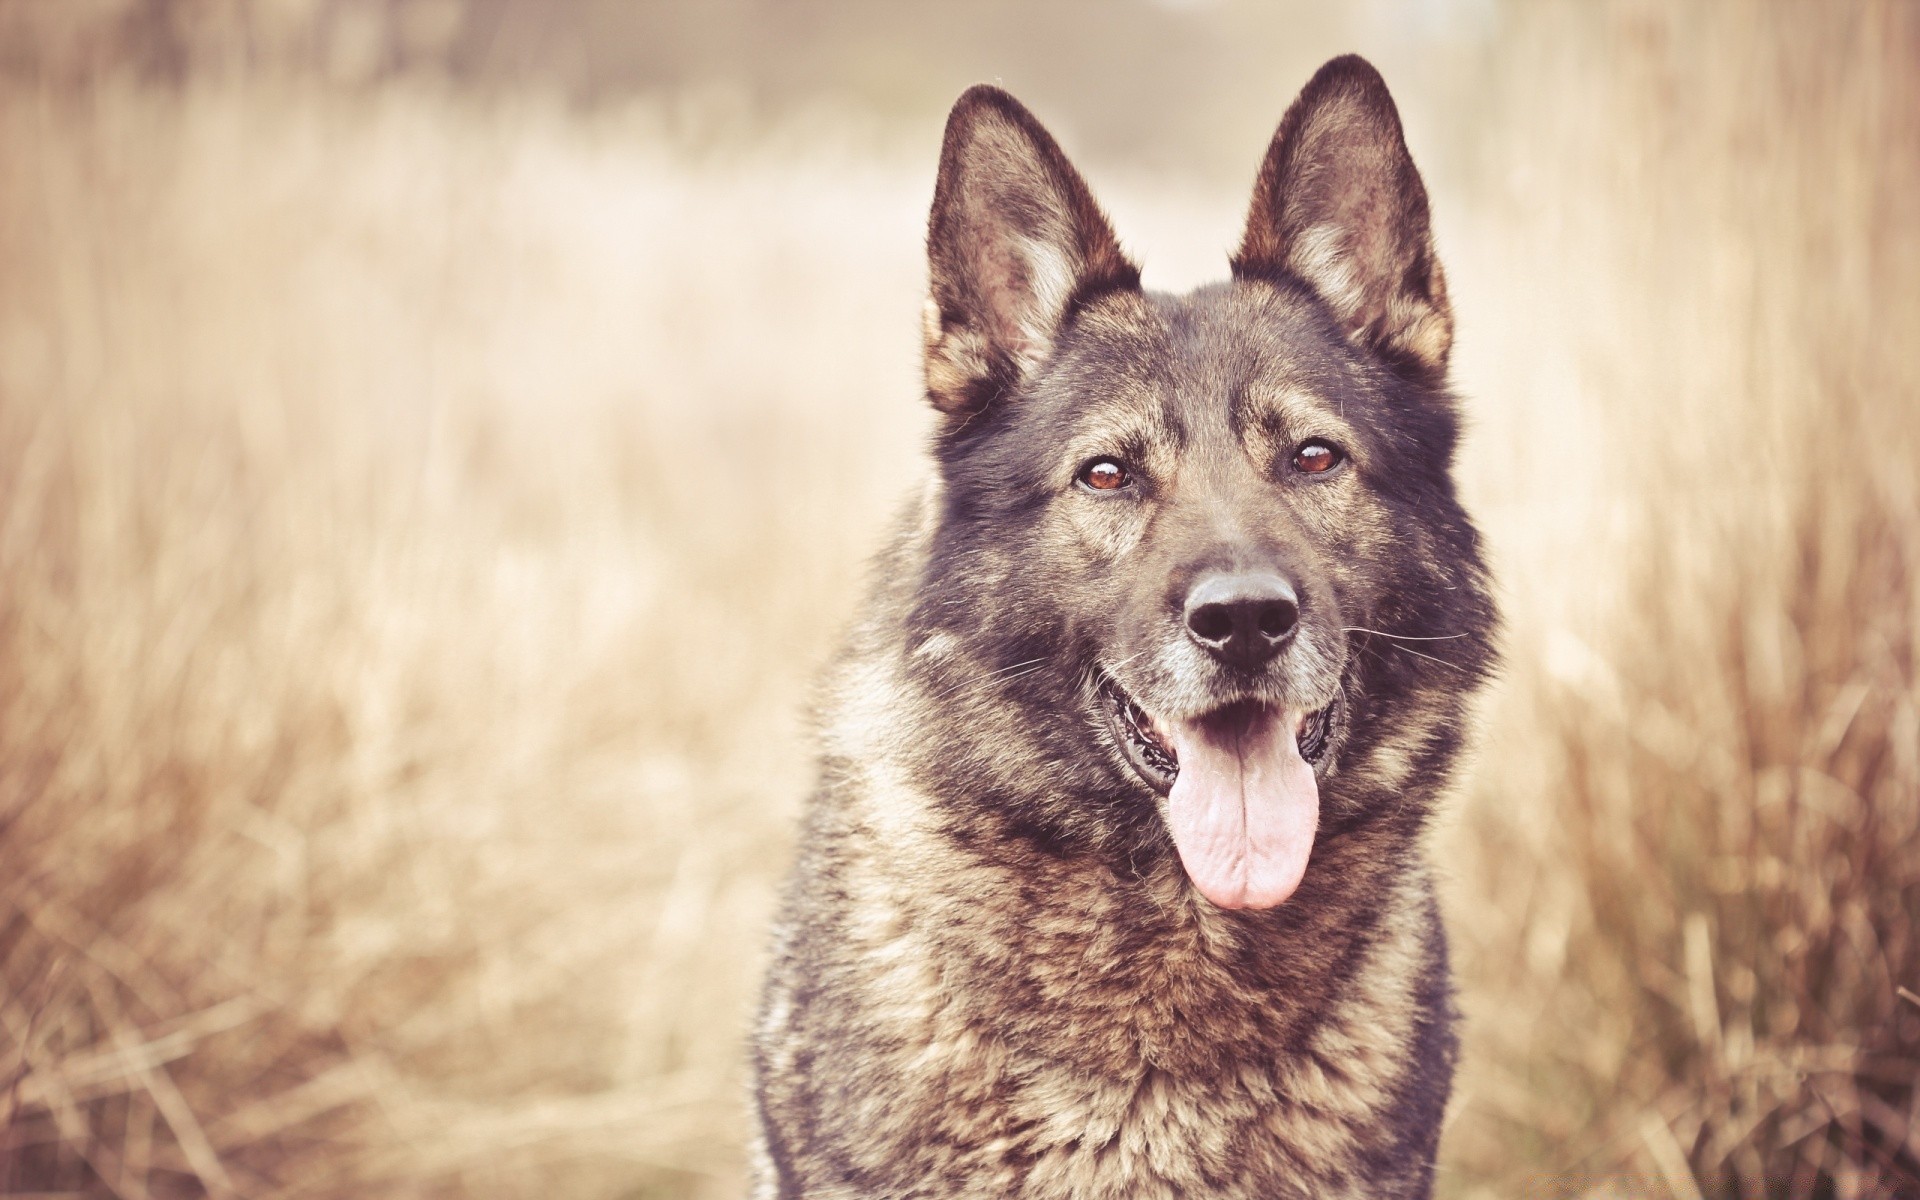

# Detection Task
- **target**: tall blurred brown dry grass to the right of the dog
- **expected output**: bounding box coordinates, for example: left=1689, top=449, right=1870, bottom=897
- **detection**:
left=1444, top=8, right=1920, bottom=1200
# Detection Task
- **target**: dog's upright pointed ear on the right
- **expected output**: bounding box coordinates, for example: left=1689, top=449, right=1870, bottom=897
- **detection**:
left=1233, top=54, right=1453, bottom=384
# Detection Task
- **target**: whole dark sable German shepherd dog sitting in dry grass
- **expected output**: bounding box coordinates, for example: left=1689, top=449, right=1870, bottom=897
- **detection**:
left=755, top=58, right=1496, bottom=1200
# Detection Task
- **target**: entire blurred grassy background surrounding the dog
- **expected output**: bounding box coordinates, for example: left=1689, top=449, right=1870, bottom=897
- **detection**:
left=0, top=0, right=1920, bottom=1200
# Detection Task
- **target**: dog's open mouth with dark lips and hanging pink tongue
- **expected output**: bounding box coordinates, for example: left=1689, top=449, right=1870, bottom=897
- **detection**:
left=1098, top=674, right=1342, bottom=908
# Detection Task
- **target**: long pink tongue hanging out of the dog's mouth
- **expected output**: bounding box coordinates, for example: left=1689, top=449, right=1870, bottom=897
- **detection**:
left=1167, top=707, right=1319, bottom=908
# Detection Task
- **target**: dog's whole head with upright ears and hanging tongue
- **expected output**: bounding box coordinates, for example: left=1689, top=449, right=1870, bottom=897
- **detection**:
left=910, top=58, right=1492, bottom=908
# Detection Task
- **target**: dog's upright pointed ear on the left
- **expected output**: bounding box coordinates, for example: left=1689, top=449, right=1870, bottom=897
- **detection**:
left=925, top=86, right=1140, bottom=419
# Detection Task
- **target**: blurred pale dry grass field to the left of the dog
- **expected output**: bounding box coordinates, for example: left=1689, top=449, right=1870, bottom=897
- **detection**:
left=0, top=79, right=922, bottom=1196
